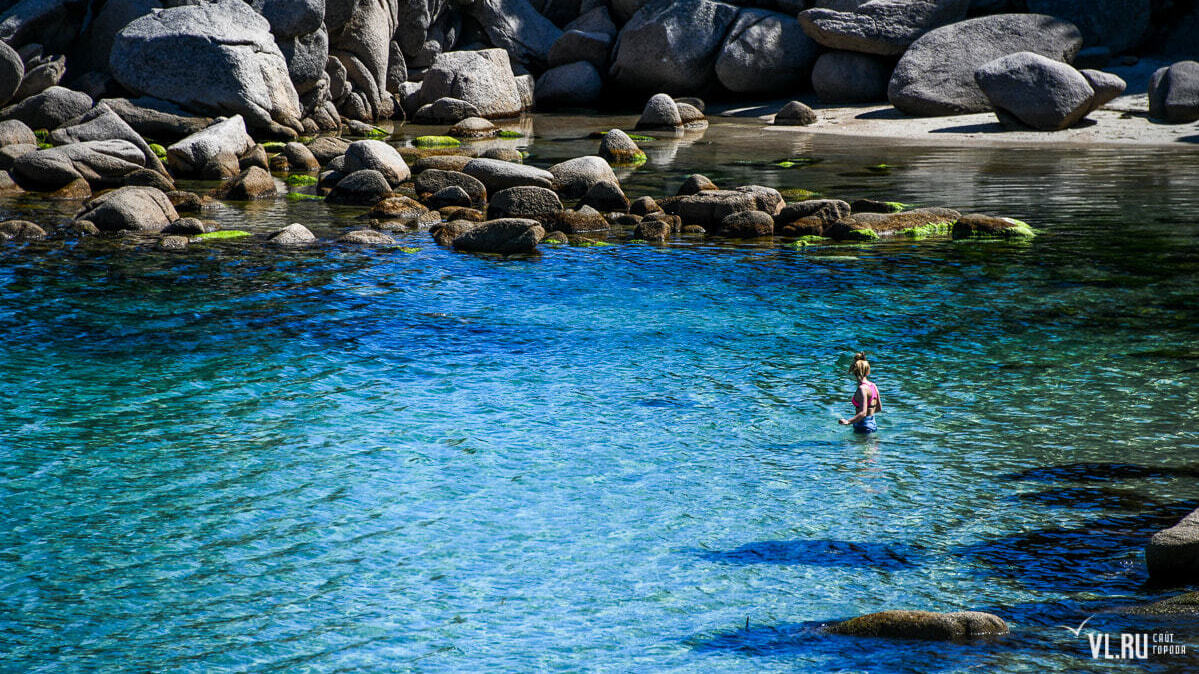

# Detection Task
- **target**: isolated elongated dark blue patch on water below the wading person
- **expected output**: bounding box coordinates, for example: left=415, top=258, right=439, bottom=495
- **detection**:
left=700, top=538, right=923, bottom=571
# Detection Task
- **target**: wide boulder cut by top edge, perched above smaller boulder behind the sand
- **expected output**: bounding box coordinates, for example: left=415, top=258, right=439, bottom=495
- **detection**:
left=800, top=0, right=970, bottom=55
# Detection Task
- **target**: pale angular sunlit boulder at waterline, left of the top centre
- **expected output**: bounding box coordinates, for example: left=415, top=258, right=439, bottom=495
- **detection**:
left=417, top=49, right=523, bottom=119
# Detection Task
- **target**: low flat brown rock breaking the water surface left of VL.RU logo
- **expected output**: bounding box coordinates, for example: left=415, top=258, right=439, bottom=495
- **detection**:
left=825, top=610, right=1008, bottom=642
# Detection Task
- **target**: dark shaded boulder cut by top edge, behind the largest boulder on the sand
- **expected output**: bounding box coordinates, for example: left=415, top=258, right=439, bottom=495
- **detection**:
left=1028, top=0, right=1151, bottom=54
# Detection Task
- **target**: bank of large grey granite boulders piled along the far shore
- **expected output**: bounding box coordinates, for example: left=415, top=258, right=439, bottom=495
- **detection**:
left=0, top=0, right=1199, bottom=140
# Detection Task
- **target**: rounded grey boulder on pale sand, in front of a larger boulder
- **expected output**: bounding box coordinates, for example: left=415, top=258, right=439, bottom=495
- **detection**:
left=975, top=52, right=1095, bottom=131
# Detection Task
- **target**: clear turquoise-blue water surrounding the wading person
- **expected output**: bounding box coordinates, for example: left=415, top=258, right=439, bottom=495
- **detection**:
left=0, top=119, right=1199, bottom=672
